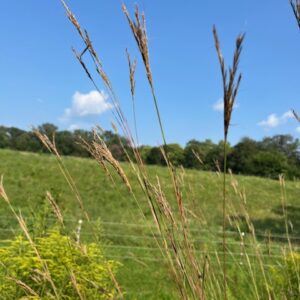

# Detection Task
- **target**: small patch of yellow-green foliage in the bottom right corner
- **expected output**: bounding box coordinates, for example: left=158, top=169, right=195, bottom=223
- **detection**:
left=272, top=253, right=300, bottom=300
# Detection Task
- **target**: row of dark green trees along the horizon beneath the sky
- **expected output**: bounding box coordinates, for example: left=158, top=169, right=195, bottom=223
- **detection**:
left=0, top=123, right=300, bottom=179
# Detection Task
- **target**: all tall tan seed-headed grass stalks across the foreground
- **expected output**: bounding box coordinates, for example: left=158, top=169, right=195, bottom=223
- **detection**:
left=0, top=1, right=300, bottom=300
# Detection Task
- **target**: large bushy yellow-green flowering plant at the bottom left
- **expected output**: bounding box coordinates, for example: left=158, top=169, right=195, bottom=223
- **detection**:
left=0, top=229, right=118, bottom=299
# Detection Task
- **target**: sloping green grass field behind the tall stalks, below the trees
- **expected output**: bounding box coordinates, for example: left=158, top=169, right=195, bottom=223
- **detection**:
left=0, top=150, right=300, bottom=299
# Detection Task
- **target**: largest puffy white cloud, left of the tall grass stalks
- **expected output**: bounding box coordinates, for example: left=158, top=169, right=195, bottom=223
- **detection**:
left=62, top=91, right=112, bottom=121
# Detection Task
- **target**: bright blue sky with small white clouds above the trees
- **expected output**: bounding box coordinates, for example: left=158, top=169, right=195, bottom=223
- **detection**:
left=0, top=0, right=300, bottom=145
